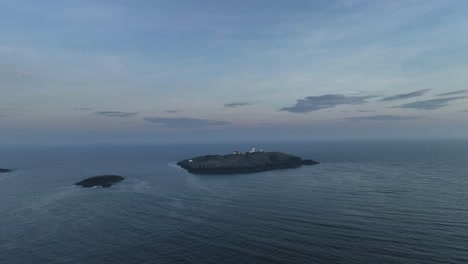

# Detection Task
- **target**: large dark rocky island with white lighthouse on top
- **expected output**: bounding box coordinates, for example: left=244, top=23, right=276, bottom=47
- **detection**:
left=177, top=148, right=319, bottom=174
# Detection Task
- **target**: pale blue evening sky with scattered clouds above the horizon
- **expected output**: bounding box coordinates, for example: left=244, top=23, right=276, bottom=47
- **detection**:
left=0, top=0, right=468, bottom=144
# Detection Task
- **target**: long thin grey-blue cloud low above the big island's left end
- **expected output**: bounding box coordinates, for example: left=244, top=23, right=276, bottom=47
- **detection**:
left=143, top=117, right=231, bottom=127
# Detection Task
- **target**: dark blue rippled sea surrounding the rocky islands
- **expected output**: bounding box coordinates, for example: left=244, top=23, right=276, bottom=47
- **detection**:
left=0, top=140, right=468, bottom=264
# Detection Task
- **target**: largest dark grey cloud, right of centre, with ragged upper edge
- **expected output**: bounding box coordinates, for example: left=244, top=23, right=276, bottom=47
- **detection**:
left=280, top=94, right=374, bottom=113
